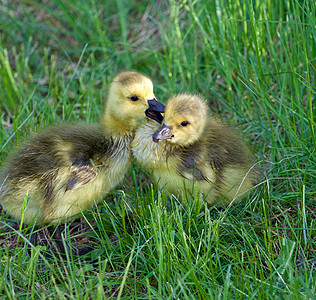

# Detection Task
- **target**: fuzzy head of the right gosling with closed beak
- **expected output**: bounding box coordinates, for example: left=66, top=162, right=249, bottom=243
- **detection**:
left=153, top=94, right=208, bottom=146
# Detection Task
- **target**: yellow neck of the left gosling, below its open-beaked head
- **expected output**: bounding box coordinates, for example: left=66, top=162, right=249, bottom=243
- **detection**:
left=101, top=109, right=137, bottom=136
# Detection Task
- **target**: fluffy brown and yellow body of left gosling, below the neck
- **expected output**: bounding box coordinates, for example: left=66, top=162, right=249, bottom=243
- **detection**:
left=0, top=124, right=131, bottom=223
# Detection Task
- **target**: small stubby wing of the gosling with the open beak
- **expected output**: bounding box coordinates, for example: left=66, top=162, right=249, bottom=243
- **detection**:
left=66, top=158, right=97, bottom=191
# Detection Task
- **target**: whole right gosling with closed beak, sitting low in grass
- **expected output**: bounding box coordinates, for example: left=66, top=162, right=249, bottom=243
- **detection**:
left=131, top=94, right=260, bottom=206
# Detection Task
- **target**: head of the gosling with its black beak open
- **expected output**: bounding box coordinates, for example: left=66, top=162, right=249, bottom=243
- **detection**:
left=105, top=71, right=164, bottom=126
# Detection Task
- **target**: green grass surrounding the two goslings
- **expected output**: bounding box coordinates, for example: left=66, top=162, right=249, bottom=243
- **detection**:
left=0, top=0, right=316, bottom=299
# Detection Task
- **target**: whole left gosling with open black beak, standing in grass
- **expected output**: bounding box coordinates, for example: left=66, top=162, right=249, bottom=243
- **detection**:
left=0, top=71, right=164, bottom=230
